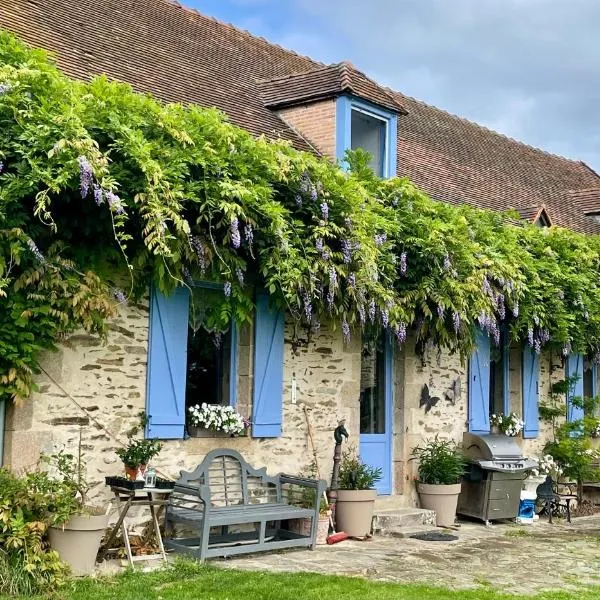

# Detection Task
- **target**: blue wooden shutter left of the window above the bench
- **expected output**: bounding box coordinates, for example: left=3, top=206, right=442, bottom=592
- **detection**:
left=146, top=288, right=189, bottom=439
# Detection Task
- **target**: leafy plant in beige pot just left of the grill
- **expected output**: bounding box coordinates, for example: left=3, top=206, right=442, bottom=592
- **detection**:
left=412, top=436, right=466, bottom=527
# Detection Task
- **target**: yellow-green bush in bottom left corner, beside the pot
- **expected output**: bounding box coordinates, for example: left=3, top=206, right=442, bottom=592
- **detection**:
left=0, top=468, right=68, bottom=595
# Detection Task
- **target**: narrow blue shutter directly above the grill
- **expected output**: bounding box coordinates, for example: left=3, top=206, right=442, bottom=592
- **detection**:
left=469, top=331, right=490, bottom=433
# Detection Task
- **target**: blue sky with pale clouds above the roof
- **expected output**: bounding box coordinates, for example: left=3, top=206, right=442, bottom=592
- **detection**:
left=189, top=0, right=600, bottom=172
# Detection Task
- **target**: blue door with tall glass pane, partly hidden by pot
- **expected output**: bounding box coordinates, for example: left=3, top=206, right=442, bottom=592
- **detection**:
left=360, top=332, right=393, bottom=494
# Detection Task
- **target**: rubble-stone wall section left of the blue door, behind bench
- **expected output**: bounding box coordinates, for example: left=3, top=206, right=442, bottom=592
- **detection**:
left=4, top=302, right=360, bottom=508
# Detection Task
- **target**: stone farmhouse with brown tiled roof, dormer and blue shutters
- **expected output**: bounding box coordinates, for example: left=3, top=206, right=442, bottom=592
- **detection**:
left=0, top=0, right=600, bottom=506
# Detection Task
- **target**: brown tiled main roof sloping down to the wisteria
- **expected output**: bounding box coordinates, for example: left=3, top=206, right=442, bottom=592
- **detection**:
left=0, top=0, right=600, bottom=232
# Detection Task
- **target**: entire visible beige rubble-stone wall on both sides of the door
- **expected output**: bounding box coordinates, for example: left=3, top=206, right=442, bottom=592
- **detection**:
left=4, top=290, right=588, bottom=506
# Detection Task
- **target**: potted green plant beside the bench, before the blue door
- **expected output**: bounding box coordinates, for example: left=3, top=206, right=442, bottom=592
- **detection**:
left=335, top=450, right=381, bottom=537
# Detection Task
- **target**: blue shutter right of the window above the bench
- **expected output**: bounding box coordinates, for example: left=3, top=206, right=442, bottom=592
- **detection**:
left=252, top=294, right=283, bottom=437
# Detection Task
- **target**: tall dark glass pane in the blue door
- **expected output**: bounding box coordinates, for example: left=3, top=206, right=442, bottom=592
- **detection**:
left=360, top=334, right=385, bottom=433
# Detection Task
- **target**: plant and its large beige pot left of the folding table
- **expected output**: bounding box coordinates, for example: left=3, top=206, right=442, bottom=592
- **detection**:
left=42, top=444, right=108, bottom=575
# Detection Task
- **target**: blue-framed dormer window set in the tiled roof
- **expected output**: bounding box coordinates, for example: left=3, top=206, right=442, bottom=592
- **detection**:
left=335, top=96, right=398, bottom=177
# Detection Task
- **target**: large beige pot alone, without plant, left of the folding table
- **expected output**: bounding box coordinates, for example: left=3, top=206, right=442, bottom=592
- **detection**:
left=48, top=514, right=108, bottom=575
